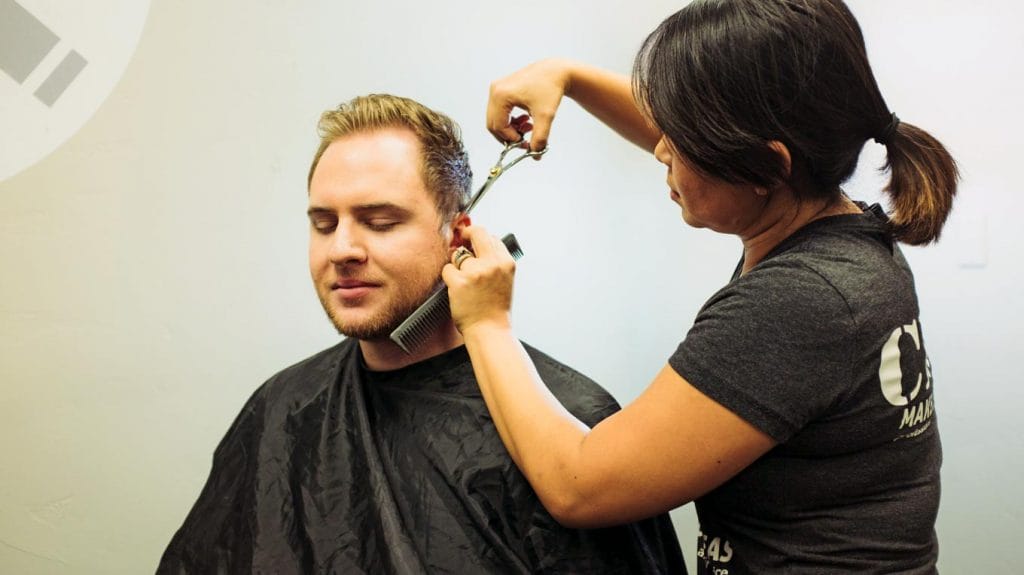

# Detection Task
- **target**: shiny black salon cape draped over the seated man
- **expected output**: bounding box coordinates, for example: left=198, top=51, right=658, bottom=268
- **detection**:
left=157, top=340, right=686, bottom=574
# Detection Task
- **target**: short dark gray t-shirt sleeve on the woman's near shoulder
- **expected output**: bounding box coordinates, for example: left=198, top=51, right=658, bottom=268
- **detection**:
left=669, top=264, right=855, bottom=442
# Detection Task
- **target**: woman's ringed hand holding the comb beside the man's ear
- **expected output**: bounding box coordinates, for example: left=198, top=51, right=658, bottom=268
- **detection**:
left=441, top=226, right=515, bottom=334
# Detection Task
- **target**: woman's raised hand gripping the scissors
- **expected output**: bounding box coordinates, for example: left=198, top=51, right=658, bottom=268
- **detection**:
left=487, top=58, right=572, bottom=151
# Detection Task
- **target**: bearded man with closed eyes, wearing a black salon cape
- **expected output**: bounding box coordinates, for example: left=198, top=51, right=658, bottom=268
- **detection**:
left=158, top=95, right=686, bottom=574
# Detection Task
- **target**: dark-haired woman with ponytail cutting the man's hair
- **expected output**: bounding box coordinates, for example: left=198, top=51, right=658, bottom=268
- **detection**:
left=443, top=0, right=957, bottom=575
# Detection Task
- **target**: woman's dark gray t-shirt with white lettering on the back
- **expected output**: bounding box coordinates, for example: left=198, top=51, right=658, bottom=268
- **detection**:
left=669, top=207, right=942, bottom=575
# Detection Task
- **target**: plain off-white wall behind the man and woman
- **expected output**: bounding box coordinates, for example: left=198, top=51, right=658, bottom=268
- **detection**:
left=0, top=0, right=1024, bottom=575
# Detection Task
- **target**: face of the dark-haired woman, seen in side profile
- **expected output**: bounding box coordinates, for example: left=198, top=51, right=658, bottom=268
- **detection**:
left=654, top=135, right=766, bottom=237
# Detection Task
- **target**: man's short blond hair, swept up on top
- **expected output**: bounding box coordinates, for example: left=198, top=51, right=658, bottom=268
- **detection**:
left=306, top=94, right=473, bottom=220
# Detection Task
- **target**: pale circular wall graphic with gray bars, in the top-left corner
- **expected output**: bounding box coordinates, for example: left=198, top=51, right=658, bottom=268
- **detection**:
left=0, top=0, right=150, bottom=181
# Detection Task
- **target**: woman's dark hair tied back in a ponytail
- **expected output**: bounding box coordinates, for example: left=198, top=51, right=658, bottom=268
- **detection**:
left=633, top=0, right=959, bottom=245
